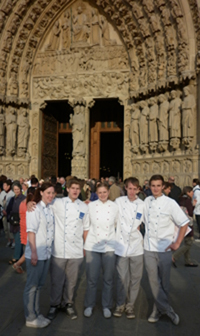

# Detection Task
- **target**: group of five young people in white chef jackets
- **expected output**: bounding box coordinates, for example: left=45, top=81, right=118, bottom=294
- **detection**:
left=24, top=175, right=189, bottom=328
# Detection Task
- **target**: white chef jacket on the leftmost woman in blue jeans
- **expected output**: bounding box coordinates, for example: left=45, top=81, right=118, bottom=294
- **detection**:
left=25, top=201, right=54, bottom=260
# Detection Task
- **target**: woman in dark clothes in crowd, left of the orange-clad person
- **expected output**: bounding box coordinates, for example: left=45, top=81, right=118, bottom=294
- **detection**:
left=6, top=181, right=25, bottom=265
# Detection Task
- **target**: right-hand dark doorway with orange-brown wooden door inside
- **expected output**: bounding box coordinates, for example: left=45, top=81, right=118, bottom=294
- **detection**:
left=90, top=98, right=124, bottom=179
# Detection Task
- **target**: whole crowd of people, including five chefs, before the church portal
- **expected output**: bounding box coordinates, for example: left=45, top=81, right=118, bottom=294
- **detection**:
left=0, top=175, right=200, bottom=328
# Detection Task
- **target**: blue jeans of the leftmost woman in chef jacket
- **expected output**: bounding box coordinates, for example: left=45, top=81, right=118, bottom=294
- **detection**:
left=24, top=258, right=50, bottom=321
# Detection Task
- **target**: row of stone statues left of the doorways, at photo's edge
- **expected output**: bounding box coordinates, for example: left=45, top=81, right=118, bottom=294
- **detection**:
left=0, top=106, right=29, bottom=158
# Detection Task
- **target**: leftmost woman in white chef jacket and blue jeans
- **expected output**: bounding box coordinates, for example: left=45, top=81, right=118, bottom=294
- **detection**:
left=24, top=182, right=55, bottom=328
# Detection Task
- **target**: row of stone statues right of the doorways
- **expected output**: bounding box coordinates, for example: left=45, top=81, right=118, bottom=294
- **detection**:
left=130, top=86, right=196, bottom=154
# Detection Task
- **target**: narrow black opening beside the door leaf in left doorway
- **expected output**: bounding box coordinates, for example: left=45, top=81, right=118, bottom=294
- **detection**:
left=58, top=133, right=72, bottom=177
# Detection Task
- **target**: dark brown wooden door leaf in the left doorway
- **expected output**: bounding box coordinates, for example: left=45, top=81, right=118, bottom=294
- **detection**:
left=42, top=113, right=58, bottom=178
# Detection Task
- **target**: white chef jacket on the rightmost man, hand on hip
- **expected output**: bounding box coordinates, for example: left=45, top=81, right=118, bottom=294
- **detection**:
left=144, top=195, right=189, bottom=252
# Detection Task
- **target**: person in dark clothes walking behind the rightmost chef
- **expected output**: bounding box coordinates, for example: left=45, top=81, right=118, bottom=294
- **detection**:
left=172, top=187, right=198, bottom=267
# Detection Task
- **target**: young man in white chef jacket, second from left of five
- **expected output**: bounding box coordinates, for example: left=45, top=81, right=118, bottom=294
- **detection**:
left=47, top=179, right=88, bottom=320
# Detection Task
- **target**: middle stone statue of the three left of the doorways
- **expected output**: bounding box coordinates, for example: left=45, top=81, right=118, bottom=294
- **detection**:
left=6, top=107, right=17, bottom=155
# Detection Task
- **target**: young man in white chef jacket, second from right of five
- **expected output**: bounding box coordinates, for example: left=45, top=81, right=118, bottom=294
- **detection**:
left=113, top=177, right=144, bottom=319
